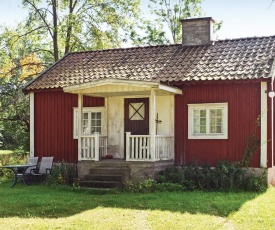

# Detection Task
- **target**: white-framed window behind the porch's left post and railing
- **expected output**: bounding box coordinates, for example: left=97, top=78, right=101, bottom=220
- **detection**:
left=74, top=107, right=106, bottom=139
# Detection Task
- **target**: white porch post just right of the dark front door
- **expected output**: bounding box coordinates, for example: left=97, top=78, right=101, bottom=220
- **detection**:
left=150, top=88, right=156, bottom=161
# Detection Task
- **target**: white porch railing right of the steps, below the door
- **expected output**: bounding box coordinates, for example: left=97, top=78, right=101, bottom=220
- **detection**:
left=126, top=132, right=174, bottom=161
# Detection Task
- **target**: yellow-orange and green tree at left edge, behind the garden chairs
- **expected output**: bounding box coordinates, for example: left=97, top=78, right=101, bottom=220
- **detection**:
left=0, top=24, right=45, bottom=150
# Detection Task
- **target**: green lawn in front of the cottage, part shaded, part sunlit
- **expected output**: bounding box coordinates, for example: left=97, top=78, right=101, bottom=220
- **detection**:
left=0, top=181, right=275, bottom=229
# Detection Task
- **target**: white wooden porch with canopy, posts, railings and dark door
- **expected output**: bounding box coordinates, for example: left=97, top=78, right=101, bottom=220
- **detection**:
left=64, top=79, right=182, bottom=162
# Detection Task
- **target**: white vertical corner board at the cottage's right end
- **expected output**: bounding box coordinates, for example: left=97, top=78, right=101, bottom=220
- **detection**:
left=261, top=82, right=267, bottom=168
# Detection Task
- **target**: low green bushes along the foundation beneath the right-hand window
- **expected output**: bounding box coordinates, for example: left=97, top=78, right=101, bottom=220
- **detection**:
left=156, top=161, right=267, bottom=191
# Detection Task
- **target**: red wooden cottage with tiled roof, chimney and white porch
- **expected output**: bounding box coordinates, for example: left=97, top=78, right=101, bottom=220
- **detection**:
left=25, top=18, right=275, bottom=182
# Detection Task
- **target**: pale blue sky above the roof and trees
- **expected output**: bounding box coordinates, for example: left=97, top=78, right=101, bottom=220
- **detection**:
left=0, top=0, right=275, bottom=39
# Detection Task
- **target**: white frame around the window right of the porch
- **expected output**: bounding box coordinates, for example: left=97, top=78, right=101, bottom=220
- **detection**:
left=188, top=103, right=228, bottom=139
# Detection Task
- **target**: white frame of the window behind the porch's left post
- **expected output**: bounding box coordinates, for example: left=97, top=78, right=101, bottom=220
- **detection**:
left=73, top=107, right=107, bottom=139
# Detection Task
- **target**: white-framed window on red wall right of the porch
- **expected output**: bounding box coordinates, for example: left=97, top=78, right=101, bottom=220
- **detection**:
left=188, top=103, right=228, bottom=139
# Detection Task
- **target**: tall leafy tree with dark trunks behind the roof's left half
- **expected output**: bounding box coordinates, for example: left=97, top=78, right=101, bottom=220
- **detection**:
left=22, top=0, right=140, bottom=61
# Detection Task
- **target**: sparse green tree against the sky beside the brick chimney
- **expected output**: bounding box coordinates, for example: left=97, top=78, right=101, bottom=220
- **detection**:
left=131, top=0, right=222, bottom=45
